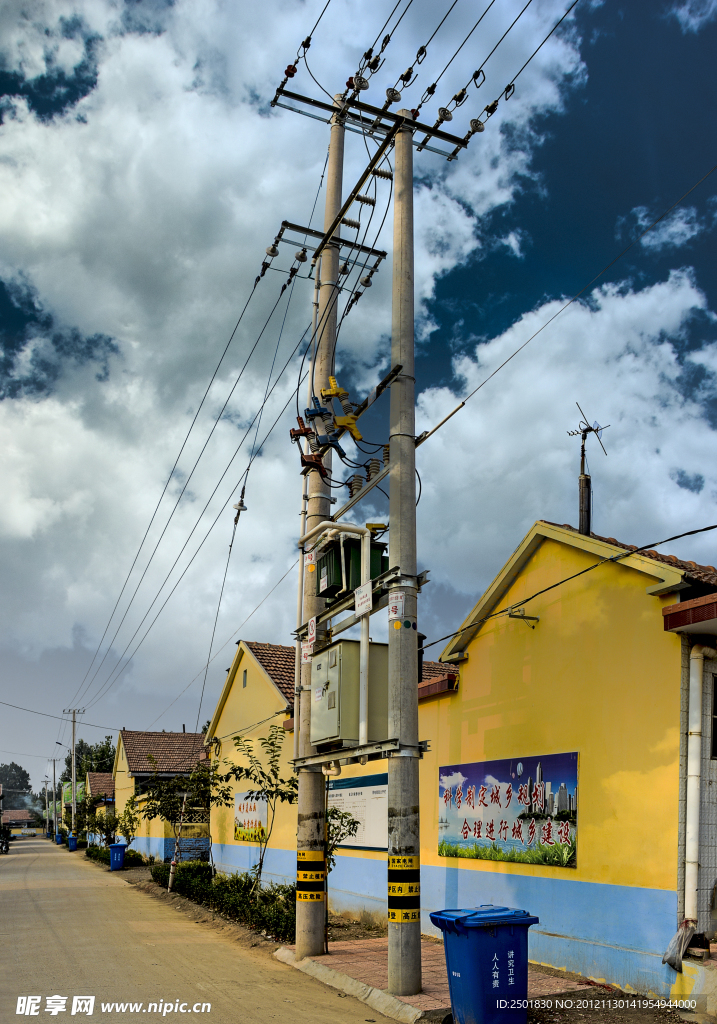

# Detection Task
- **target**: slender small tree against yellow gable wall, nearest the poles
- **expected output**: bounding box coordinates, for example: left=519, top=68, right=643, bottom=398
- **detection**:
left=227, top=725, right=299, bottom=886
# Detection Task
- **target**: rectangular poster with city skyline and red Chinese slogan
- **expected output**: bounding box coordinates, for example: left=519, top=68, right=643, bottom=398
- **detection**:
left=438, top=752, right=578, bottom=867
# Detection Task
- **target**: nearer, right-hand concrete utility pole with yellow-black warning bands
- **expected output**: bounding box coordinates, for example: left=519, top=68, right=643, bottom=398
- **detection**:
left=388, top=110, right=421, bottom=995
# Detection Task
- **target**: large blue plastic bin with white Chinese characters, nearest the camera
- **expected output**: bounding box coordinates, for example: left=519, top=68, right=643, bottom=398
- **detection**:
left=430, top=905, right=539, bottom=1024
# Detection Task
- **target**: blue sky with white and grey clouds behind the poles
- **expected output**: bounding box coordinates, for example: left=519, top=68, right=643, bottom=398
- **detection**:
left=0, top=0, right=717, bottom=783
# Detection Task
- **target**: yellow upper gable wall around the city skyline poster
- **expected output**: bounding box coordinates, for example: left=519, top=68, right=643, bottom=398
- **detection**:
left=419, top=540, right=681, bottom=889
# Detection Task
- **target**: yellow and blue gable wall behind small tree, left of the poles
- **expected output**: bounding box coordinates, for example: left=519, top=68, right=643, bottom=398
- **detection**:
left=211, top=648, right=296, bottom=869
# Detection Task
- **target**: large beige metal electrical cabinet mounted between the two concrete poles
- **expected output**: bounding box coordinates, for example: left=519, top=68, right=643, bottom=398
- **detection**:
left=311, top=640, right=388, bottom=749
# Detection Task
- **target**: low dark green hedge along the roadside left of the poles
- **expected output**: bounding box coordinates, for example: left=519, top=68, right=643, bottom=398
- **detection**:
left=152, top=860, right=296, bottom=942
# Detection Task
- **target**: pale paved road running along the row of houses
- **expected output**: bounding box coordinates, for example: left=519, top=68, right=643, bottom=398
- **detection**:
left=0, top=838, right=386, bottom=1024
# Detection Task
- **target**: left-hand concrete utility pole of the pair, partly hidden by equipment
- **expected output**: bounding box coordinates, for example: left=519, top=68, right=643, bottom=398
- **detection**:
left=294, top=96, right=344, bottom=959
